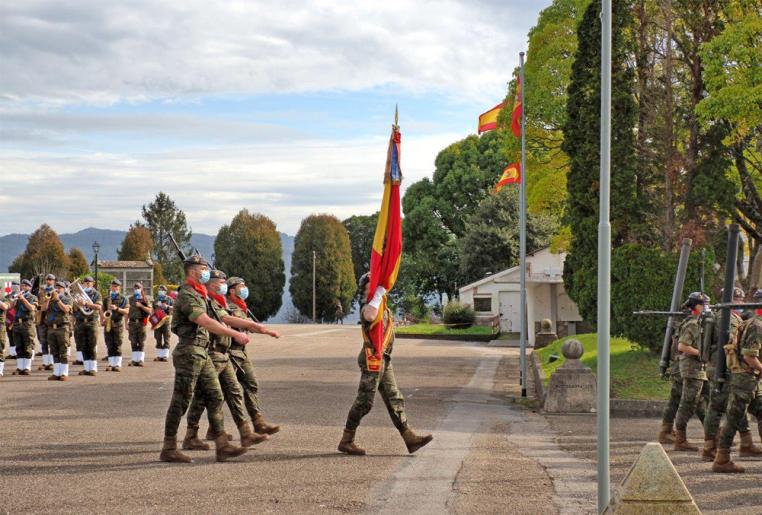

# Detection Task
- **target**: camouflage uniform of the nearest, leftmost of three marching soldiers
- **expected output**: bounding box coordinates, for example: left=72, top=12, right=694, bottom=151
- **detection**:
left=164, top=284, right=225, bottom=439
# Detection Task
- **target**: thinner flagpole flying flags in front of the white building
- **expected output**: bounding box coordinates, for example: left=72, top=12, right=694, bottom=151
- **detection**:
left=519, top=52, right=527, bottom=397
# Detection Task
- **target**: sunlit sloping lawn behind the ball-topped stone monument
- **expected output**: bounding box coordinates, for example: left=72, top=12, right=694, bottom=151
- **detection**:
left=537, top=333, right=669, bottom=400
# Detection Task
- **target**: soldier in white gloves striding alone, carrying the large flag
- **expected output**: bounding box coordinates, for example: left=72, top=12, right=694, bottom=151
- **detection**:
left=338, top=273, right=434, bottom=456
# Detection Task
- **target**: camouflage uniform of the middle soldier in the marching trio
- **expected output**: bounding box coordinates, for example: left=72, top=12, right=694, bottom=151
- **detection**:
left=187, top=299, right=249, bottom=434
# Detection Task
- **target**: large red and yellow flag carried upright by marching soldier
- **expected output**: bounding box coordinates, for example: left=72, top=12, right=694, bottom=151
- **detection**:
left=365, top=120, right=402, bottom=372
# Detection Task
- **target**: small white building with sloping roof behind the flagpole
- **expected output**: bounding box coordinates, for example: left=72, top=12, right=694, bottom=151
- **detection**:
left=460, top=248, right=582, bottom=345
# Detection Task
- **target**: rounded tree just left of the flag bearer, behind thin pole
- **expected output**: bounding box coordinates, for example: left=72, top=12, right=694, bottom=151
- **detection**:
left=289, top=215, right=357, bottom=322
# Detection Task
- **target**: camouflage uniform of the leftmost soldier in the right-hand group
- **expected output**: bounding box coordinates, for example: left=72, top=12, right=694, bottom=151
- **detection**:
left=675, top=315, right=707, bottom=432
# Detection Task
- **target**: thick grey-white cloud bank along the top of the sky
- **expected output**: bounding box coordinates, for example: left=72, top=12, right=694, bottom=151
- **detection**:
left=0, top=0, right=539, bottom=104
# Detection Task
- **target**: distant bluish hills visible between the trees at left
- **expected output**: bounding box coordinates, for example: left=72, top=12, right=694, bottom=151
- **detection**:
left=0, top=227, right=294, bottom=323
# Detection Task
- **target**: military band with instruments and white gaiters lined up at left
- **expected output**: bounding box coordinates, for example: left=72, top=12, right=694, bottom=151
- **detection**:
left=0, top=274, right=174, bottom=381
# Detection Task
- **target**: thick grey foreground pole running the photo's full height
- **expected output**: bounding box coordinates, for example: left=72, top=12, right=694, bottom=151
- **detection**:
left=597, top=0, right=611, bottom=513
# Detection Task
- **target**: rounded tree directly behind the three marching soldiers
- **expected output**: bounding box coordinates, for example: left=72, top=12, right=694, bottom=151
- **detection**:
left=214, top=209, right=286, bottom=320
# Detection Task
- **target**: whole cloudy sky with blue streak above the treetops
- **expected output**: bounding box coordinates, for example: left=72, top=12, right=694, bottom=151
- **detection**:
left=0, top=0, right=550, bottom=235
